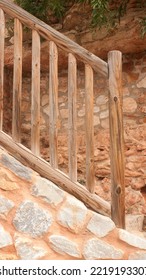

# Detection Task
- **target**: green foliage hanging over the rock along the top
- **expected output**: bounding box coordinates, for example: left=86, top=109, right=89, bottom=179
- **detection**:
left=15, top=0, right=146, bottom=36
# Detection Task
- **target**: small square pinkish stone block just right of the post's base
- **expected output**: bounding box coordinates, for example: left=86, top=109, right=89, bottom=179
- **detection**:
left=125, top=214, right=144, bottom=231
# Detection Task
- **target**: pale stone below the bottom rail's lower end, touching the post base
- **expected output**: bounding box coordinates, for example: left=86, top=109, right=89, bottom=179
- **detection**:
left=87, top=213, right=115, bottom=237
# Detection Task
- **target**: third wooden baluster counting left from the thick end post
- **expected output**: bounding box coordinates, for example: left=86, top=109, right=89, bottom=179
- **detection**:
left=49, top=41, right=58, bottom=168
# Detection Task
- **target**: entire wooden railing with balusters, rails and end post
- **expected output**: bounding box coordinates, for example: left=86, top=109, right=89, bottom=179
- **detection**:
left=0, top=0, right=125, bottom=227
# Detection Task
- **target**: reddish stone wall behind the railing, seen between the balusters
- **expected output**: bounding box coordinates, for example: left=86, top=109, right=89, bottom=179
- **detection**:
left=4, top=52, right=146, bottom=214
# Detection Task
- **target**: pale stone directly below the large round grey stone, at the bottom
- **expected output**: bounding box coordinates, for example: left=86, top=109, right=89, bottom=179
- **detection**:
left=14, top=237, right=48, bottom=260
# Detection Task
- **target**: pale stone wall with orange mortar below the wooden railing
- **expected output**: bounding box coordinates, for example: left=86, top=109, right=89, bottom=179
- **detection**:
left=0, top=148, right=146, bottom=260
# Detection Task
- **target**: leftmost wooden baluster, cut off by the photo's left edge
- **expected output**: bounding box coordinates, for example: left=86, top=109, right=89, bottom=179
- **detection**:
left=0, top=9, right=5, bottom=130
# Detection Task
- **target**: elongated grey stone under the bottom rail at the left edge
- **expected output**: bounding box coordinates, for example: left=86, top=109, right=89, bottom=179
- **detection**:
left=0, top=154, right=32, bottom=181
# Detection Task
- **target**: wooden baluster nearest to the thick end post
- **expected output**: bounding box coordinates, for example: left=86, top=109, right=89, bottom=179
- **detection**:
left=85, top=64, right=95, bottom=193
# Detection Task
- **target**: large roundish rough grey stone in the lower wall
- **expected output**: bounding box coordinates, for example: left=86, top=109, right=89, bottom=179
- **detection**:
left=13, top=200, right=52, bottom=237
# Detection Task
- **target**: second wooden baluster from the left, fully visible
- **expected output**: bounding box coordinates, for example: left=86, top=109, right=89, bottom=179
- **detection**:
left=12, top=18, right=22, bottom=142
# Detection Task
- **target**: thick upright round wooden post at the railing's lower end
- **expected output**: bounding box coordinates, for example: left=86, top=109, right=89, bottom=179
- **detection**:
left=108, top=51, right=125, bottom=228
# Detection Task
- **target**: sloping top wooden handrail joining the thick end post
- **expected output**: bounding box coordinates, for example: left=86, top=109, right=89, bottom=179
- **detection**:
left=0, top=0, right=108, bottom=77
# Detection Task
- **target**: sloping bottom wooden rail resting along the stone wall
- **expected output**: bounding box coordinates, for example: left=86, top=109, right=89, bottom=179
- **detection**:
left=0, top=131, right=110, bottom=216
